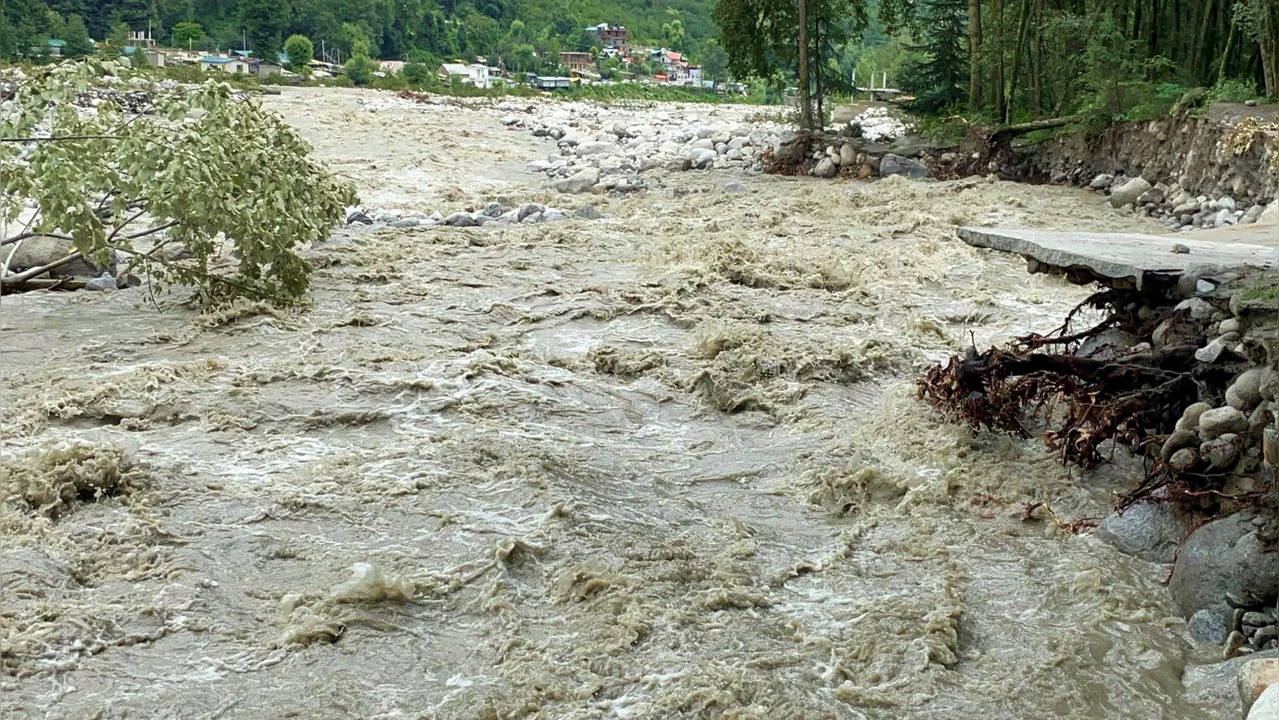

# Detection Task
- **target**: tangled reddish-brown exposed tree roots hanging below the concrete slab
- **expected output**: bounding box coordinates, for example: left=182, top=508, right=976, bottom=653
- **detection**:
left=918, top=290, right=1248, bottom=508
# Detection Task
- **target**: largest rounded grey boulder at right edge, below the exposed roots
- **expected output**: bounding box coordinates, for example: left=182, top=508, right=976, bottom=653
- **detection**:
left=1168, top=510, right=1279, bottom=618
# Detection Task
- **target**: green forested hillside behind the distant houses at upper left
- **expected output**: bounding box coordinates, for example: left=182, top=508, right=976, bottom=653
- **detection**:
left=0, top=0, right=715, bottom=65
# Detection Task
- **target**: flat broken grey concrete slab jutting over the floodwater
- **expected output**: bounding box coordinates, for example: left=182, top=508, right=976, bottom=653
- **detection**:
left=957, top=228, right=1279, bottom=289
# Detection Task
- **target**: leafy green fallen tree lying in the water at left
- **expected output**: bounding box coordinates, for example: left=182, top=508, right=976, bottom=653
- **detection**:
left=0, top=57, right=354, bottom=303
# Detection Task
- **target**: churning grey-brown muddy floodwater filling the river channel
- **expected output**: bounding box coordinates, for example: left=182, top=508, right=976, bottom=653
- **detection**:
left=0, top=90, right=1233, bottom=719
